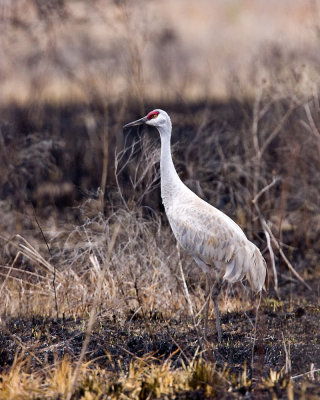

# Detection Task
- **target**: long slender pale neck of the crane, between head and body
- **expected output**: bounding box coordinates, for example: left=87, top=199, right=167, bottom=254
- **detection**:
left=158, top=124, right=184, bottom=208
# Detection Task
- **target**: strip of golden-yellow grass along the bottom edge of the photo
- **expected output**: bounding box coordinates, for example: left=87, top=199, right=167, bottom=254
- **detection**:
left=0, top=356, right=316, bottom=400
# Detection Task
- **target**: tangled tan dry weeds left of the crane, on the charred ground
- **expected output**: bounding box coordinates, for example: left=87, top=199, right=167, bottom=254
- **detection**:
left=0, top=202, right=203, bottom=317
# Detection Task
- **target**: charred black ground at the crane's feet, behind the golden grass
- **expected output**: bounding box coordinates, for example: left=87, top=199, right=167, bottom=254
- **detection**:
left=0, top=279, right=320, bottom=398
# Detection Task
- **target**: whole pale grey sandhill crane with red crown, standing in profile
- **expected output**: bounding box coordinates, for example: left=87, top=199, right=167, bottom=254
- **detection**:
left=124, top=109, right=266, bottom=343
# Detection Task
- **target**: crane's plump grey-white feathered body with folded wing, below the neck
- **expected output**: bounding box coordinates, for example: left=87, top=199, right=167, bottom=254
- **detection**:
left=167, top=199, right=266, bottom=291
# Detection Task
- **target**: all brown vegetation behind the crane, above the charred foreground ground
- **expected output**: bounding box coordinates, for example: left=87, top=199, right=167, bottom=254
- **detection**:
left=0, top=0, right=320, bottom=314
